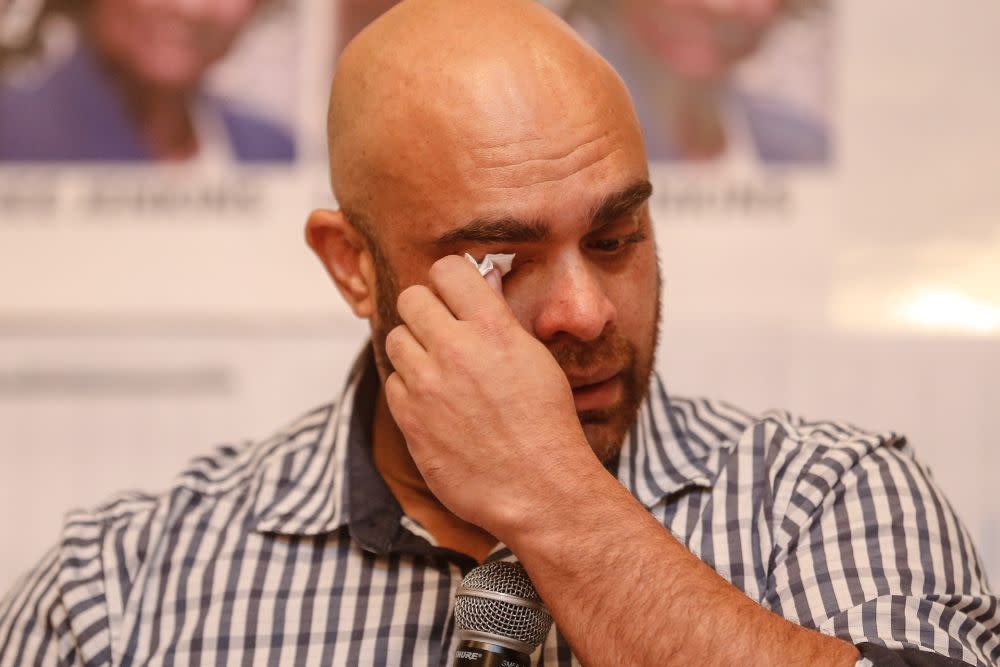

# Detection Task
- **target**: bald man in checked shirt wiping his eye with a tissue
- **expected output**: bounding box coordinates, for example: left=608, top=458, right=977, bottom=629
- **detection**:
left=0, top=0, right=1000, bottom=665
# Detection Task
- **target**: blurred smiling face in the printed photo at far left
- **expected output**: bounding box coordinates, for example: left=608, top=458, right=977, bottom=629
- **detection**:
left=88, top=0, right=257, bottom=90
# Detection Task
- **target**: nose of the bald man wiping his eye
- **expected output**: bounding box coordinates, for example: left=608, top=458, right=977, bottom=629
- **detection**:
left=532, top=255, right=617, bottom=341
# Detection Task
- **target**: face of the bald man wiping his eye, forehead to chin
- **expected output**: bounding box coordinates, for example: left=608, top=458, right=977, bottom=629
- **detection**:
left=364, top=60, right=659, bottom=460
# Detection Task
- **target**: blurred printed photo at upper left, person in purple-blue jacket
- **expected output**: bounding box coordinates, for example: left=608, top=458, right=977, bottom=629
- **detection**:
left=0, top=0, right=299, bottom=167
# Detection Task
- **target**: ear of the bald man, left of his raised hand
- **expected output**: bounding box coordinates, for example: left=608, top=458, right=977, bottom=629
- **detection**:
left=305, top=209, right=375, bottom=319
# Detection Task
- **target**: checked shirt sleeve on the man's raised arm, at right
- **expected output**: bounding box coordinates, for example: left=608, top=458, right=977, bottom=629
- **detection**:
left=769, top=438, right=1000, bottom=667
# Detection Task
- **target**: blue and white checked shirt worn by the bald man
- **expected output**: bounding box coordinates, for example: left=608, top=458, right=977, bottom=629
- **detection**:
left=0, top=350, right=1000, bottom=665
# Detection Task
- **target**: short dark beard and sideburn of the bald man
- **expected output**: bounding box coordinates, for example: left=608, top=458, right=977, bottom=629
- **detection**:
left=372, top=244, right=661, bottom=465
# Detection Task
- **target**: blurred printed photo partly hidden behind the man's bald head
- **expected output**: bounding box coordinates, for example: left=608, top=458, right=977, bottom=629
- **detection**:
left=337, top=0, right=834, bottom=172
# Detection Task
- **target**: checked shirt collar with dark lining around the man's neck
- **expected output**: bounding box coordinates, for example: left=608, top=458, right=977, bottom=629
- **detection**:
left=254, top=344, right=720, bottom=540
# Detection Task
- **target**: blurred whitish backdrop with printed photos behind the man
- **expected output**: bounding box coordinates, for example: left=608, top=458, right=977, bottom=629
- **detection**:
left=0, top=0, right=1000, bottom=590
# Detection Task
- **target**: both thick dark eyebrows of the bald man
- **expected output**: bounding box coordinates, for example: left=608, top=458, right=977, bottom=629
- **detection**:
left=434, top=179, right=653, bottom=246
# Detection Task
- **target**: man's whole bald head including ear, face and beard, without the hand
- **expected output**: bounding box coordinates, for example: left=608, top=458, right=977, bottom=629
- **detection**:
left=306, top=0, right=659, bottom=459
